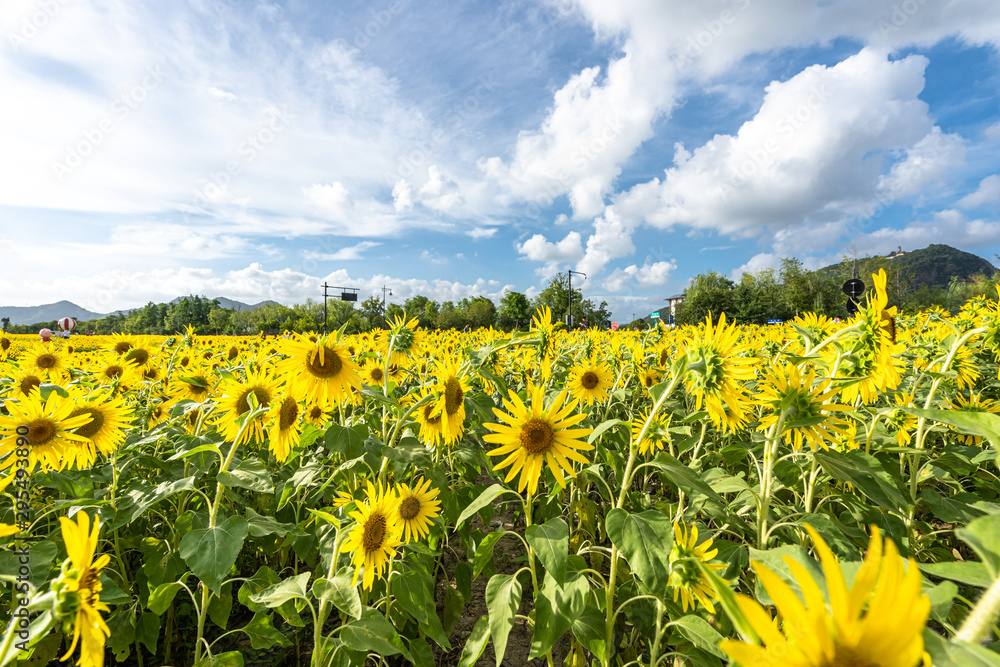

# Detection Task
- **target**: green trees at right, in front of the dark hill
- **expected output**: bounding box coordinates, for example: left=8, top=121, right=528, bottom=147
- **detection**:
left=675, top=257, right=1000, bottom=324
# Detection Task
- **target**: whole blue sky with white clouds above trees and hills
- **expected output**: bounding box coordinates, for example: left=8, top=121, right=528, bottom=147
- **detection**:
left=0, top=0, right=1000, bottom=319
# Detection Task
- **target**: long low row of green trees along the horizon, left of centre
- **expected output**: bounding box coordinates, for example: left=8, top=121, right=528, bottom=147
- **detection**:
left=3, top=277, right=611, bottom=335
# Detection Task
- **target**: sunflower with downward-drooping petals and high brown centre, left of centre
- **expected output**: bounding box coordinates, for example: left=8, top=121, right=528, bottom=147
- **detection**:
left=275, top=336, right=361, bottom=405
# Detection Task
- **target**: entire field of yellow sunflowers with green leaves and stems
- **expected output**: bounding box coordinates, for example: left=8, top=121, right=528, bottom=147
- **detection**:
left=0, top=274, right=1000, bottom=667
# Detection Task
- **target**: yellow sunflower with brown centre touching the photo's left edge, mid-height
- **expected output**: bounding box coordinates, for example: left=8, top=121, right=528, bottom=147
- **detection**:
left=0, top=391, right=91, bottom=481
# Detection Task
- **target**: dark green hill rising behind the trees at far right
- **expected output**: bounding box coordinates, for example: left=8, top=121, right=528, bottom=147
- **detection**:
left=820, top=243, right=997, bottom=288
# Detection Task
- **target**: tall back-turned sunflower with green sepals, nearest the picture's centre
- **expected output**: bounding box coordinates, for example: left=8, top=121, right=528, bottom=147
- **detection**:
left=684, top=313, right=756, bottom=430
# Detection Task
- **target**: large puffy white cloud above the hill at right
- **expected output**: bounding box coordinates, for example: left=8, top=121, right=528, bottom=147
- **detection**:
left=581, top=48, right=964, bottom=271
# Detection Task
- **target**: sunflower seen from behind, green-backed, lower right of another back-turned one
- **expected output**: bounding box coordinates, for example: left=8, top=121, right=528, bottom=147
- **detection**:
left=758, top=364, right=852, bottom=451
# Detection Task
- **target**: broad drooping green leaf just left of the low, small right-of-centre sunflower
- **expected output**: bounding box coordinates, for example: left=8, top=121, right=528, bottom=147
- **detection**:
left=605, top=508, right=674, bottom=598
